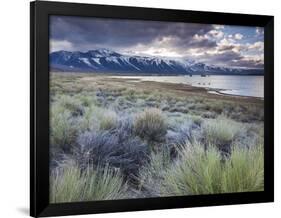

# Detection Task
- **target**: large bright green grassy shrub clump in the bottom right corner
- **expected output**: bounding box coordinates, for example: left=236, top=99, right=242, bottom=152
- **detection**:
left=162, top=145, right=264, bottom=196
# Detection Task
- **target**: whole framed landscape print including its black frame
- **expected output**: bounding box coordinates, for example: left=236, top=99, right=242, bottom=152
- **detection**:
left=30, top=1, right=274, bottom=217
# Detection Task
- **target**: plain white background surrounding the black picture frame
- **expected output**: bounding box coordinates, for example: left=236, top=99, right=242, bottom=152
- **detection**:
left=0, top=0, right=276, bottom=218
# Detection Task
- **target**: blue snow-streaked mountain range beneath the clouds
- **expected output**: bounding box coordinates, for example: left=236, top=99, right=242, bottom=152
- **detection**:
left=50, top=49, right=263, bottom=75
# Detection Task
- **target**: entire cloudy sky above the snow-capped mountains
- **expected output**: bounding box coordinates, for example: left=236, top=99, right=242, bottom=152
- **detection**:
left=50, top=16, right=264, bottom=68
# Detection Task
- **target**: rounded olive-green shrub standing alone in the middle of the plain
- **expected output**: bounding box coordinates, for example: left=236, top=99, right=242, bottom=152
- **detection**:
left=134, top=108, right=167, bottom=141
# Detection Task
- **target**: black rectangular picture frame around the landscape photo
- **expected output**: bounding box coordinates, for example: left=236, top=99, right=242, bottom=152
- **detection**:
left=30, top=1, right=274, bottom=217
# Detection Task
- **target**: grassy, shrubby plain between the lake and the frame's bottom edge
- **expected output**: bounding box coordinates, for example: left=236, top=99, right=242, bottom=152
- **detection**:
left=50, top=73, right=264, bottom=203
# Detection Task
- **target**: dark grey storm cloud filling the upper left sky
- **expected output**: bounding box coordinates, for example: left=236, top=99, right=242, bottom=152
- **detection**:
left=50, top=16, right=213, bottom=47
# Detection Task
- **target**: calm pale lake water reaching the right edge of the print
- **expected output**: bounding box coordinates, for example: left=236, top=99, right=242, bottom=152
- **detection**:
left=111, top=75, right=264, bottom=98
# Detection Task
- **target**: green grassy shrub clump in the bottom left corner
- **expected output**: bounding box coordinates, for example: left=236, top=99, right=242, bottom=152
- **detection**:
left=50, top=162, right=126, bottom=203
